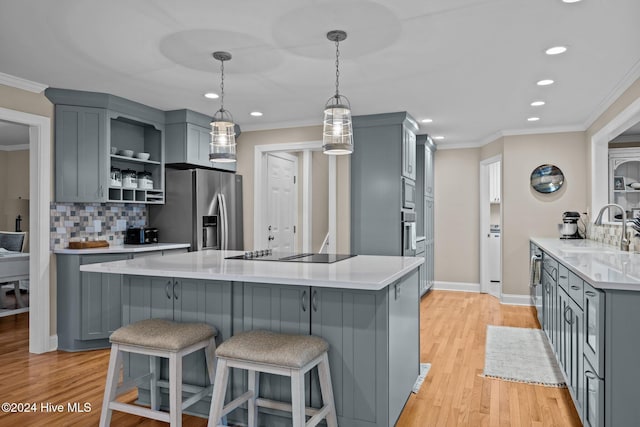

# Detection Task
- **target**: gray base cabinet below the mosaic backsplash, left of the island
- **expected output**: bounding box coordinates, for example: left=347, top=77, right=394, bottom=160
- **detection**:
left=56, top=253, right=130, bottom=351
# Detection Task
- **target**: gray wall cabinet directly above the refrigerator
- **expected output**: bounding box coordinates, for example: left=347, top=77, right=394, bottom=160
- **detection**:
left=165, top=109, right=237, bottom=172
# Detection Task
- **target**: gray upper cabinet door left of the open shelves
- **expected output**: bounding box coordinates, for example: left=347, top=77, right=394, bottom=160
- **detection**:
left=55, top=105, right=109, bottom=202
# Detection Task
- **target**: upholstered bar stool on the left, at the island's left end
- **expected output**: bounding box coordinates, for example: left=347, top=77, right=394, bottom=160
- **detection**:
left=100, top=319, right=218, bottom=427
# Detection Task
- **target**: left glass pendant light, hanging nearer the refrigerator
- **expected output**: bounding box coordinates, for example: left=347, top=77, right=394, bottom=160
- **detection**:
left=209, top=52, right=236, bottom=163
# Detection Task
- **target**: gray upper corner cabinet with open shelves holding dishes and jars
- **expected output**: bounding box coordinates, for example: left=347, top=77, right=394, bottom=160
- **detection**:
left=45, top=88, right=164, bottom=204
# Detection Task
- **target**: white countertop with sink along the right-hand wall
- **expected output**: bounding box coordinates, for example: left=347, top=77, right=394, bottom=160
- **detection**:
left=531, top=237, right=640, bottom=291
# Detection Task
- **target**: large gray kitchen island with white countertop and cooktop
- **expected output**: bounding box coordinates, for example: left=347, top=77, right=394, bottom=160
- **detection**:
left=80, top=251, right=424, bottom=427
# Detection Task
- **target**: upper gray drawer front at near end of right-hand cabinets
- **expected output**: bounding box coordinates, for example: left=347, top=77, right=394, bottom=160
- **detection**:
left=582, top=282, right=605, bottom=378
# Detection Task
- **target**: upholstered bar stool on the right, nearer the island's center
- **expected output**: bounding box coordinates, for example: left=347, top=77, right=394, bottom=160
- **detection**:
left=208, top=331, right=338, bottom=427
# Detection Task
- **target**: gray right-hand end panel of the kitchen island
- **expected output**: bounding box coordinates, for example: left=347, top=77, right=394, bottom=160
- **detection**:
left=388, top=271, right=420, bottom=425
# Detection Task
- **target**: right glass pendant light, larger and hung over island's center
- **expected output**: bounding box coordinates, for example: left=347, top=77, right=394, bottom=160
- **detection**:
left=322, top=30, right=353, bottom=155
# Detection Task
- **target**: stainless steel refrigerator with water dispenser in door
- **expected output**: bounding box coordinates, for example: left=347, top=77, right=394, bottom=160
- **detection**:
left=149, top=169, right=243, bottom=251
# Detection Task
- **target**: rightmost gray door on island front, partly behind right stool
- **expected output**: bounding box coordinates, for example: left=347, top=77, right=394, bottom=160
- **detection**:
left=311, top=288, right=388, bottom=427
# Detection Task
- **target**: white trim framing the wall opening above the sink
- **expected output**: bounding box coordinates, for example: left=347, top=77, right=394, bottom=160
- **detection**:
left=590, top=98, right=640, bottom=216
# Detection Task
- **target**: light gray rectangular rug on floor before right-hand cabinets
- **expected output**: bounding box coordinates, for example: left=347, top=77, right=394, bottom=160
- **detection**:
left=484, top=325, right=566, bottom=387
